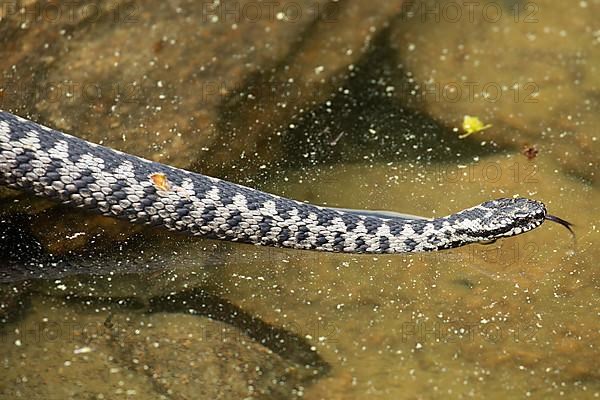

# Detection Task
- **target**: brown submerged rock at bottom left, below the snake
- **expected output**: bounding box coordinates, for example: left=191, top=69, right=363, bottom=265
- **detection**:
left=0, top=297, right=325, bottom=399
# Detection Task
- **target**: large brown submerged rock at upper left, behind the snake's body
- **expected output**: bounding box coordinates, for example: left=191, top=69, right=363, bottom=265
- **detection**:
left=0, top=0, right=408, bottom=253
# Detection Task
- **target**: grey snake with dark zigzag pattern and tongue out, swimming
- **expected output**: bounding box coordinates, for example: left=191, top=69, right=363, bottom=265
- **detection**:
left=0, top=111, right=572, bottom=254
